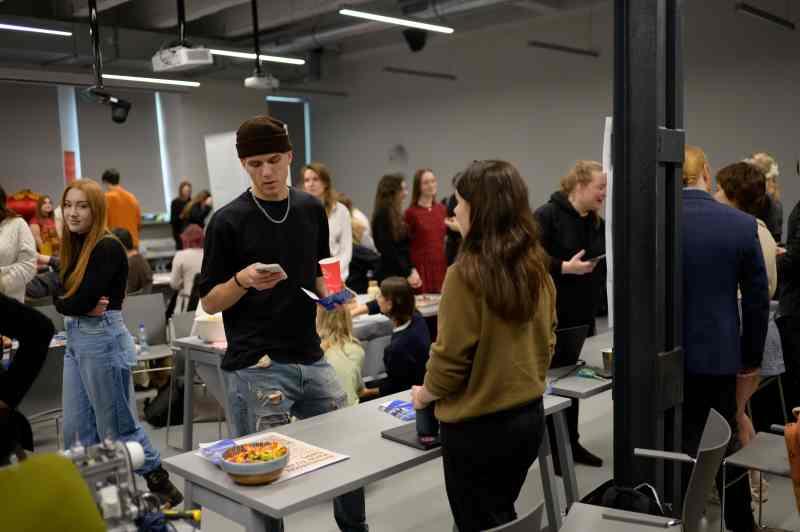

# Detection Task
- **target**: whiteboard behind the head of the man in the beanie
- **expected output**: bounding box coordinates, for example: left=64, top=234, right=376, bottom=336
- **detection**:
left=205, top=131, right=292, bottom=213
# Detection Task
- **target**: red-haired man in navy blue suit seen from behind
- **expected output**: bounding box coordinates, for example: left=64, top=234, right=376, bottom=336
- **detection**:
left=681, top=146, right=769, bottom=532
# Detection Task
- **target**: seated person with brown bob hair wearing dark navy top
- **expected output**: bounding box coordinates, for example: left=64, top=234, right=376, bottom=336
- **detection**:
left=377, top=277, right=431, bottom=396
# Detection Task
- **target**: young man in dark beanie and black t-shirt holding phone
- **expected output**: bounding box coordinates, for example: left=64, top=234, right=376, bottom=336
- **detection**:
left=198, top=116, right=369, bottom=532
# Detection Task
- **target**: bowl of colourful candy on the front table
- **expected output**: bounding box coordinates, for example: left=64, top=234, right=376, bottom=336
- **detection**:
left=220, top=441, right=289, bottom=486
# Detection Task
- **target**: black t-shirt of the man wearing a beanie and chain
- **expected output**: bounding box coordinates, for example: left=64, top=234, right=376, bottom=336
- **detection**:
left=197, top=189, right=330, bottom=371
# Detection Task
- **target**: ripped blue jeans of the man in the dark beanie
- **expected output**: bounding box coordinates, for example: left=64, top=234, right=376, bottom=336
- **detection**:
left=226, top=358, right=369, bottom=532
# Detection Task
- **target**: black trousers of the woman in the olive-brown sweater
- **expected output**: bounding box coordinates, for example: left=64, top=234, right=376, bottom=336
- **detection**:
left=441, top=398, right=544, bottom=532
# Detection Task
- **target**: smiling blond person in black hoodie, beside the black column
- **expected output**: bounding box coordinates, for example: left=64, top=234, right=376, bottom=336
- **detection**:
left=534, top=161, right=607, bottom=467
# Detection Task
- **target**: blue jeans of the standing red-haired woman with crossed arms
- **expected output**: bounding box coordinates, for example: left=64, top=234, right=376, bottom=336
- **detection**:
left=62, top=310, right=161, bottom=475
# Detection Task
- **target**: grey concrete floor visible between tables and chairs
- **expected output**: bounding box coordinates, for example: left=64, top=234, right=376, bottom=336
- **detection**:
left=29, top=318, right=800, bottom=532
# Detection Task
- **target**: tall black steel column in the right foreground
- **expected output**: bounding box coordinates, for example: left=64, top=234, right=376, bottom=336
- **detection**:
left=613, top=0, right=684, bottom=512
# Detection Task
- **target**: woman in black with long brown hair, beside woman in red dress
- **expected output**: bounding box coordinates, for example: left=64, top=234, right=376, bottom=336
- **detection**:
left=372, top=174, right=422, bottom=288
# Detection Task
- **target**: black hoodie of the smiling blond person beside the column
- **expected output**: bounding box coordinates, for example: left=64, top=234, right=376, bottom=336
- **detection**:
left=534, top=191, right=606, bottom=328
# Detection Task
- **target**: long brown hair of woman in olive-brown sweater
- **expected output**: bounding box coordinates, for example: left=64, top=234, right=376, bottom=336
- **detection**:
left=454, top=160, right=555, bottom=322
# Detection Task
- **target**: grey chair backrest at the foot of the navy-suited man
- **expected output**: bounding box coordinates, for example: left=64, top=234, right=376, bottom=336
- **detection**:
left=681, top=408, right=731, bottom=532
